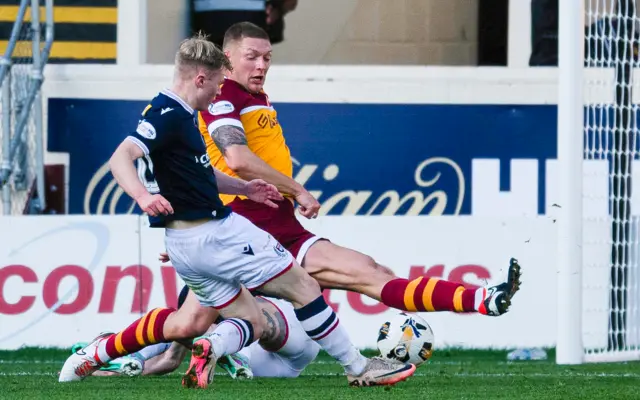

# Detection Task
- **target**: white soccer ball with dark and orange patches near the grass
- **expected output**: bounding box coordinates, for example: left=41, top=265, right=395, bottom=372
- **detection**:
left=378, top=312, right=434, bottom=367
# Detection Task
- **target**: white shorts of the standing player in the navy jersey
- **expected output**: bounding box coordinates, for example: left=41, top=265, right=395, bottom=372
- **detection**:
left=165, top=213, right=293, bottom=308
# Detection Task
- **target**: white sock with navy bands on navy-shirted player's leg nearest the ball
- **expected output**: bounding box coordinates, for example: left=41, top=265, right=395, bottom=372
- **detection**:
left=295, top=296, right=367, bottom=376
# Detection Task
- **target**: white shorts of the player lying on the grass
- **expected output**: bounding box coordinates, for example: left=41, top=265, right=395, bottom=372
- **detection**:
left=249, top=297, right=320, bottom=378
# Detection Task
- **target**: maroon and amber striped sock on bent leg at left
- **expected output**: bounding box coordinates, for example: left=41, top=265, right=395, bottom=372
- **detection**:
left=97, top=308, right=175, bottom=363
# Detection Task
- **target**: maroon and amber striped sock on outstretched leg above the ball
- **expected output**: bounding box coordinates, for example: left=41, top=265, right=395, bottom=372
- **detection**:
left=381, top=277, right=478, bottom=313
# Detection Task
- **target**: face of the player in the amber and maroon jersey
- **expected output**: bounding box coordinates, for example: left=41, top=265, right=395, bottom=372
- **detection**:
left=228, top=38, right=271, bottom=93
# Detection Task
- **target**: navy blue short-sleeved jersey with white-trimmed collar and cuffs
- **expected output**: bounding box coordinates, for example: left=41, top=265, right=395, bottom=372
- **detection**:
left=127, top=90, right=231, bottom=227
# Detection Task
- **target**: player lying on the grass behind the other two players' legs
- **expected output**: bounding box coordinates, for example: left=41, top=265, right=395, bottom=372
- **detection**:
left=72, top=286, right=320, bottom=378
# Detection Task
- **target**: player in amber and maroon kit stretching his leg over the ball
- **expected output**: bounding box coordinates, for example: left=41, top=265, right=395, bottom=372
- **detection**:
left=199, top=22, right=520, bottom=316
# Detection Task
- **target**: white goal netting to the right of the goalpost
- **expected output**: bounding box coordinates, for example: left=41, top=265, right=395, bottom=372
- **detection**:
left=582, top=0, right=640, bottom=361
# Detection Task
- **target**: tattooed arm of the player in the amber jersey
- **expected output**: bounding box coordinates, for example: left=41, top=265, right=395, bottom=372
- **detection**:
left=211, top=125, right=320, bottom=218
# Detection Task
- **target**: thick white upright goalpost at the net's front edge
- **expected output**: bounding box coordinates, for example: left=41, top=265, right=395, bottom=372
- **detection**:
left=556, top=0, right=584, bottom=364
